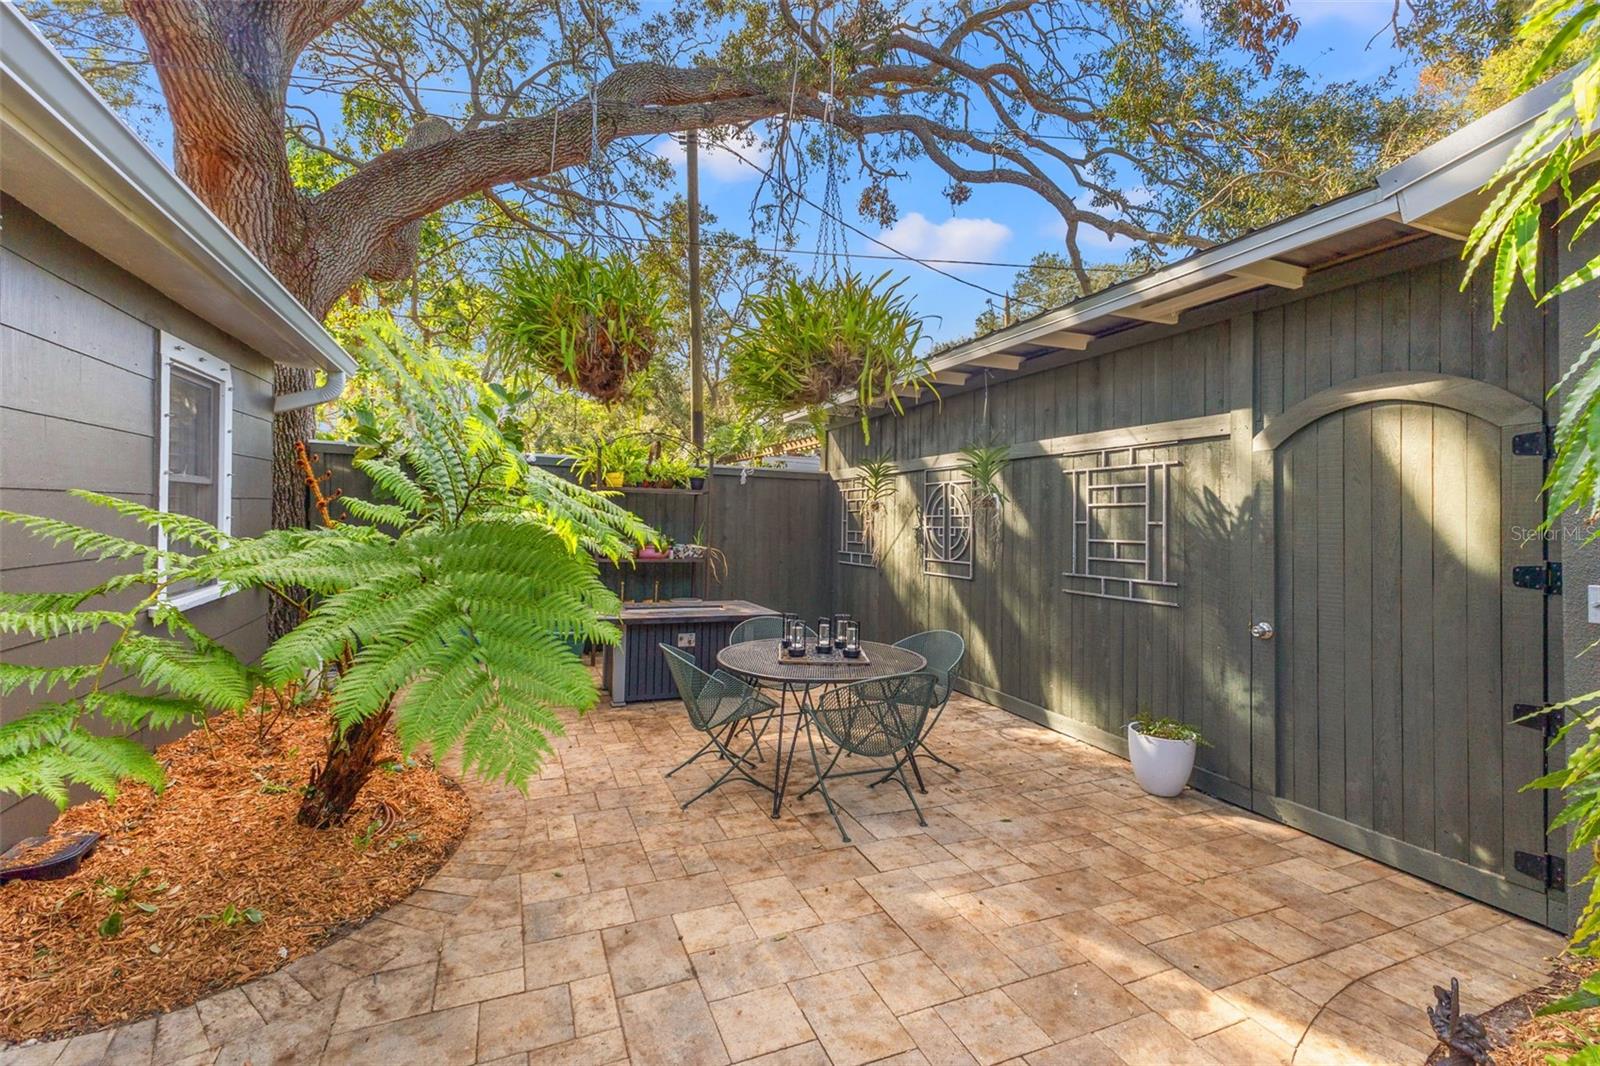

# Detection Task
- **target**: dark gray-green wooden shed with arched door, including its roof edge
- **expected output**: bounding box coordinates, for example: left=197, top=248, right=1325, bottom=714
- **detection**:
left=826, top=78, right=1600, bottom=927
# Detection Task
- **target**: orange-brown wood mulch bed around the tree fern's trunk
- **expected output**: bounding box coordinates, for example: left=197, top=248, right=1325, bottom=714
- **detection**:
left=0, top=709, right=470, bottom=1042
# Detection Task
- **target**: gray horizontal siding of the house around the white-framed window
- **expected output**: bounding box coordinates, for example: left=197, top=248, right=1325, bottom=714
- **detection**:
left=0, top=198, right=272, bottom=847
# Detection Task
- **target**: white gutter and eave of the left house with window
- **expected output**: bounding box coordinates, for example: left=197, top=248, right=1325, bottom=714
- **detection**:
left=0, top=3, right=355, bottom=375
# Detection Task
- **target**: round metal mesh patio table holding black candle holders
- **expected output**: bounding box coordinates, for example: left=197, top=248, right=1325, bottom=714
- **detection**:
left=717, top=640, right=928, bottom=818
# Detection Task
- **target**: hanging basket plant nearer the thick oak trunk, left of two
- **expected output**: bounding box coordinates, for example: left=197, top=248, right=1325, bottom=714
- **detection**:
left=491, top=250, right=666, bottom=403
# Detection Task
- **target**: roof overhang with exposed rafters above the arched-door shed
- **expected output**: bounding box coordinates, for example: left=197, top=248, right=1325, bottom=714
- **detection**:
left=787, top=65, right=1574, bottom=421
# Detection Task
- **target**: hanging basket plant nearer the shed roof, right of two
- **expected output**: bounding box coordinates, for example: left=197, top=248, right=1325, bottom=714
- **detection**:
left=728, top=274, right=928, bottom=435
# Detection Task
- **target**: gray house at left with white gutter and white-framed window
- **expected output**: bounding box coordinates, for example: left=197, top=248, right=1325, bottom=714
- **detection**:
left=0, top=6, right=354, bottom=847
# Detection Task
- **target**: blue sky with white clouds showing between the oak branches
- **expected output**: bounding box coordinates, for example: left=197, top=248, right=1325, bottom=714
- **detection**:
left=84, top=0, right=1402, bottom=344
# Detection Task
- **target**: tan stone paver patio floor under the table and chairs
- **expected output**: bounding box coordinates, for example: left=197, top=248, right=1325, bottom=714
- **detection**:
left=3, top=696, right=1560, bottom=1066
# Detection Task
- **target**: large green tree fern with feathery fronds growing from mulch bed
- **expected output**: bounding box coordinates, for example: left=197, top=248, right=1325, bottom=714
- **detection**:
left=0, top=335, right=656, bottom=828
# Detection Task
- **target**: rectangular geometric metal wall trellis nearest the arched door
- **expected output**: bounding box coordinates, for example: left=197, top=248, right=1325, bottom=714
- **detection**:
left=1062, top=447, right=1179, bottom=607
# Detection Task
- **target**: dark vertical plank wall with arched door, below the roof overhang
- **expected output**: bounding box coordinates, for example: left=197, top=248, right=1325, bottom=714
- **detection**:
left=829, top=238, right=1547, bottom=919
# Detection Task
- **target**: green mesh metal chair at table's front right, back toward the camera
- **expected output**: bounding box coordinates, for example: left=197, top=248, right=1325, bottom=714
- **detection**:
left=800, top=674, right=934, bottom=844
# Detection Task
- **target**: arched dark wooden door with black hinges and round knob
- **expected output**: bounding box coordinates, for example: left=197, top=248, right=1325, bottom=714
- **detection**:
left=1253, top=373, right=1547, bottom=922
